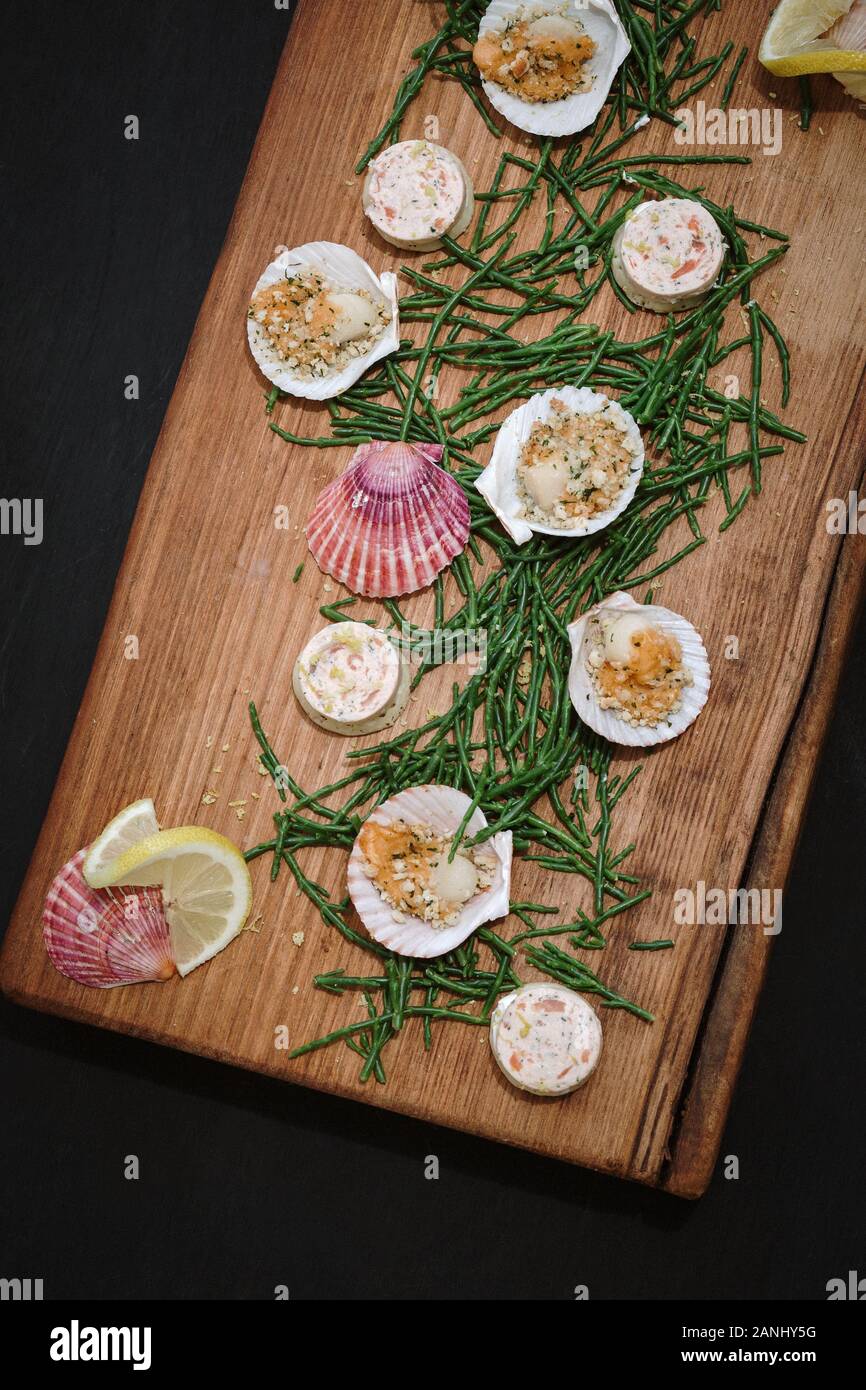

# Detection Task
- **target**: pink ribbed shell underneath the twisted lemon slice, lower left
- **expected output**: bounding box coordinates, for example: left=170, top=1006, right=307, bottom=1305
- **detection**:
left=42, top=849, right=175, bottom=990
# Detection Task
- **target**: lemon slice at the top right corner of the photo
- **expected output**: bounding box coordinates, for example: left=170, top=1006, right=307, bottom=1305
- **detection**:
left=758, top=0, right=866, bottom=78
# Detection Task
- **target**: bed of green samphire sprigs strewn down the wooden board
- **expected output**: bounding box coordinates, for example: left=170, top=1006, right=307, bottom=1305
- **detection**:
left=247, top=0, right=803, bottom=1083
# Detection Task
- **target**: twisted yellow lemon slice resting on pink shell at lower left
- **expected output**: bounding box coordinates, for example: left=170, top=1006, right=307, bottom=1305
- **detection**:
left=89, top=826, right=253, bottom=974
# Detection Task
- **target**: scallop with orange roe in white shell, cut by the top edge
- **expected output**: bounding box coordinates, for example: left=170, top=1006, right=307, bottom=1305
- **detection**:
left=474, top=0, right=631, bottom=135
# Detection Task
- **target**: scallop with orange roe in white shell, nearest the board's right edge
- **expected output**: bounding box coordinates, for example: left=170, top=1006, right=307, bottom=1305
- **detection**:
left=569, top=592, right=710, bottom=748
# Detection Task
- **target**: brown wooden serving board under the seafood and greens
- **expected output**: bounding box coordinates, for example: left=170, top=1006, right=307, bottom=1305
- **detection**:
left=1, top=0, right=865, bottom=1195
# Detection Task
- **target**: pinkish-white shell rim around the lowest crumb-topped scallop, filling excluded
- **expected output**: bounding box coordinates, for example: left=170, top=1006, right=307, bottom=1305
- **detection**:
left=346, top=785, right=512, bottom=960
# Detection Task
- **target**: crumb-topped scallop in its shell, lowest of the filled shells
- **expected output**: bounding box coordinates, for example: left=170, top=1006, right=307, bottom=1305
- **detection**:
left=348, top=785, right=512, bottom=959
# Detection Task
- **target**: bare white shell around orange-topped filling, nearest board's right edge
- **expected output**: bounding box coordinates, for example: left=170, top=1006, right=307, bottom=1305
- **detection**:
left=569, top=591, right=710, bottom=748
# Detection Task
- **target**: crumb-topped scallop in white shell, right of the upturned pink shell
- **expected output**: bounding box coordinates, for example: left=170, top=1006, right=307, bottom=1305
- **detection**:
left=475, top=386, right=644, bottom=545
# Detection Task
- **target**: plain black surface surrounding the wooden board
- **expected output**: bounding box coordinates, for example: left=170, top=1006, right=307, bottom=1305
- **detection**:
left=0, top=0, right=866, bottom=1300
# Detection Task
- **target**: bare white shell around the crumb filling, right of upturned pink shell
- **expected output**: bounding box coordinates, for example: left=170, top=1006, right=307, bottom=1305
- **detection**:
left=475, top=386, right=644, bottom=545
